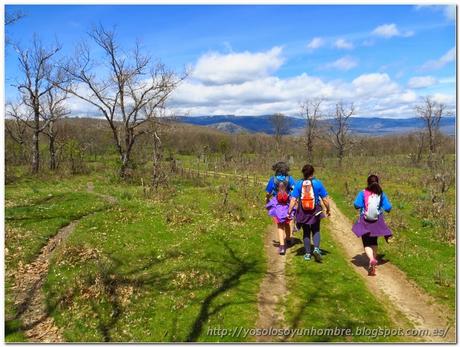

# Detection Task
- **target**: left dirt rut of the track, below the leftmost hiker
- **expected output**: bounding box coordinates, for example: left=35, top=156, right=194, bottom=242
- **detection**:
left=256, top=226, right=286, bottom=342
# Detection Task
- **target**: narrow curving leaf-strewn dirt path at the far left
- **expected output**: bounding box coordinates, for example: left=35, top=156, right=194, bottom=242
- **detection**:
left=15, top=182, right=116, bottom=342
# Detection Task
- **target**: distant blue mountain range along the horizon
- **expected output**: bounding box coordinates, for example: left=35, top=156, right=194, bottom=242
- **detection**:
left=176, top=115, right=455, bottom=136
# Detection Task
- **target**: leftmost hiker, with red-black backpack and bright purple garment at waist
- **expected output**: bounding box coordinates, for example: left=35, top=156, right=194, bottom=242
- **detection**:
left=265, top=161, right=295, bottom=255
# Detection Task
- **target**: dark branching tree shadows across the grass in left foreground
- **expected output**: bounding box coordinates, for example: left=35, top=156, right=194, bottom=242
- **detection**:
left=36, top=242, right=260, bottom=342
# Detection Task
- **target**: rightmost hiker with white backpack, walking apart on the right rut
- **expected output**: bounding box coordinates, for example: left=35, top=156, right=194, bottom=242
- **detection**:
left=352, top=175, right=393, bottom=276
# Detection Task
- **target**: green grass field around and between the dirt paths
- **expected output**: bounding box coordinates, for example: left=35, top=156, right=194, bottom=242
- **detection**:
left=5, top=156, right=455, bottom=342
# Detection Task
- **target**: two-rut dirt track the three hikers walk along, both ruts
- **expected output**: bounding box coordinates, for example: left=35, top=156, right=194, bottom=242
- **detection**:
left=181, top=169, right=455, bottom=342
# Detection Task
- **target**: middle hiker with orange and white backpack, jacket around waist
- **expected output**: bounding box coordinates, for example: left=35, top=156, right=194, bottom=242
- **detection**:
left=288, top=164, right=331, bottom=262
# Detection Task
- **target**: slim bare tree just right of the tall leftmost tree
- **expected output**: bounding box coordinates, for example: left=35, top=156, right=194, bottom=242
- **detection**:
left=42, top=88, right=70, bottom=170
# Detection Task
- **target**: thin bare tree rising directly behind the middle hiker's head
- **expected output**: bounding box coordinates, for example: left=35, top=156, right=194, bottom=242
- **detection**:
left=300, top=99, right=322, bottom=163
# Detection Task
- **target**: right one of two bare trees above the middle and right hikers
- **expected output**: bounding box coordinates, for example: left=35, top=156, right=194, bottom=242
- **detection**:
left=329, top=102, right=355, bottom=166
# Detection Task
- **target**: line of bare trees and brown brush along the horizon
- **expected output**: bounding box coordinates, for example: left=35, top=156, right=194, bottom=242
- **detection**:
left=5, top=14, right=449, bottom=186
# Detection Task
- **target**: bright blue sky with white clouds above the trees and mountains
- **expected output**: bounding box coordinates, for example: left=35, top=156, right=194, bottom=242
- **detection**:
left=5, top=5, right=456, bottom=117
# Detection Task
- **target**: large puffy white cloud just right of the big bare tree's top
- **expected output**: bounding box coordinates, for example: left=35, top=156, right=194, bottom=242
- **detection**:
left=192, top=47, right=283, bottom=84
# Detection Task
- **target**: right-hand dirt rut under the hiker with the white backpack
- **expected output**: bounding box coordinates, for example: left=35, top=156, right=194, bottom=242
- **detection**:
left=329, top=201, right=455, bottom=342
